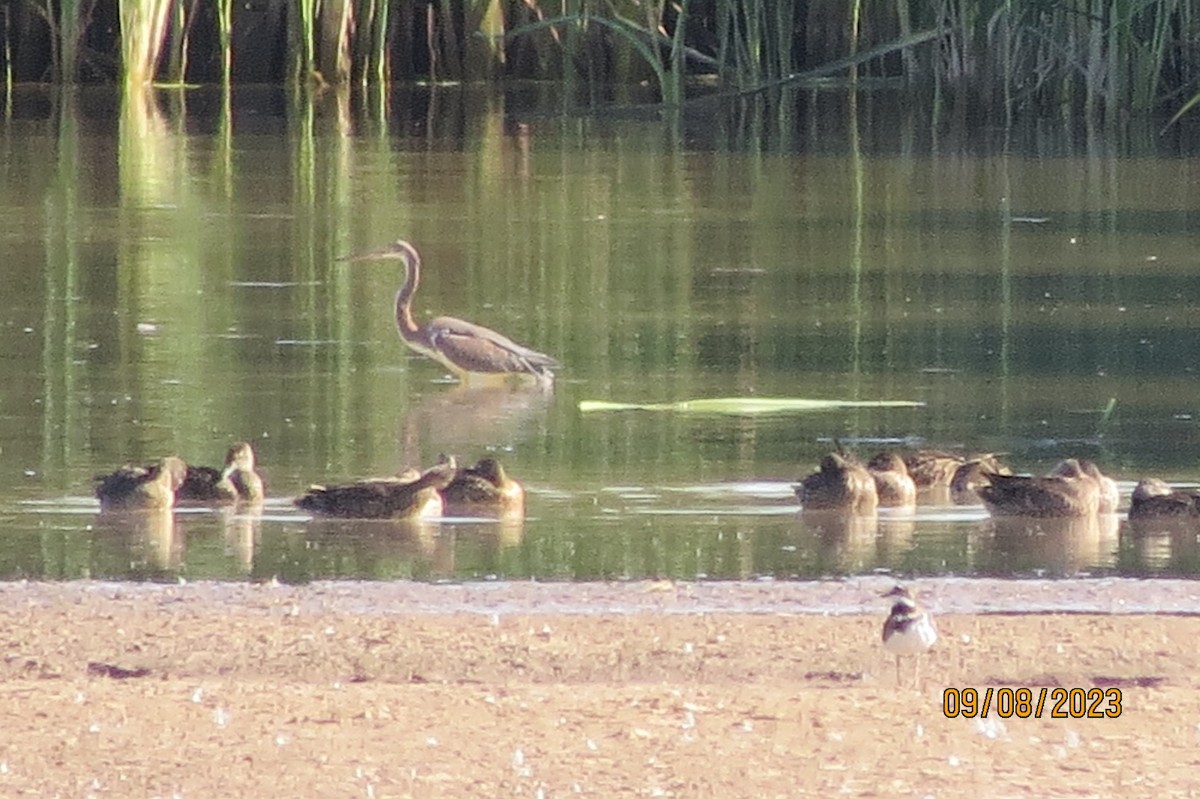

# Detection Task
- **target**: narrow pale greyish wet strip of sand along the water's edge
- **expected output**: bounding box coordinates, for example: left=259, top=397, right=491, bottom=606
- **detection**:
left=0, top=576, right=1200, bottom=615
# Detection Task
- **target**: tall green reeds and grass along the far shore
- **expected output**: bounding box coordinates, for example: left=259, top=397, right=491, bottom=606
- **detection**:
left=0, top=0, right=1200, bottom=118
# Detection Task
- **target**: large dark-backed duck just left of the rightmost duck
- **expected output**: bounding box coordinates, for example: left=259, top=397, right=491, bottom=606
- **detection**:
left=977, top=458, right=1100, bottom=518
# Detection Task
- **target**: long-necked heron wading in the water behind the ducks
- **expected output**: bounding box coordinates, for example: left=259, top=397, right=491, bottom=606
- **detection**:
left=341, top=240, right=560, bottom=380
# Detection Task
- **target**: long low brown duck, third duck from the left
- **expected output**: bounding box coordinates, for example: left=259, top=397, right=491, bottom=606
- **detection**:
left=294, top=457, right=457, bottom=519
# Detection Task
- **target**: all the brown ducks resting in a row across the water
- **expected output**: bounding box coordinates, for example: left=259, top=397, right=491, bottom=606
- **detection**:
left=96, top=441, right=1200, bottom=519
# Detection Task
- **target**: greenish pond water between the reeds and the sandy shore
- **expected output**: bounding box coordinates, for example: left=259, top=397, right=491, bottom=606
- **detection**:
left=0, top=89, right=1200, bottom=581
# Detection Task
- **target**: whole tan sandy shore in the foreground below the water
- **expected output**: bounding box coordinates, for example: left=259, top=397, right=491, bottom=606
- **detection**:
left=0, top=577, right=1200, bottom=797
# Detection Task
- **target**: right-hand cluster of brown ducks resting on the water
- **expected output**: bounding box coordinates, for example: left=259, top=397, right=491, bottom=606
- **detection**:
left=794, top=450, right=1200, bottom=519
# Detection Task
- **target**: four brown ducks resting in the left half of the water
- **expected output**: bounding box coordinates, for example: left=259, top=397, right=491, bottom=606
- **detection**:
left=96, top=441, right=524, bottom=521
